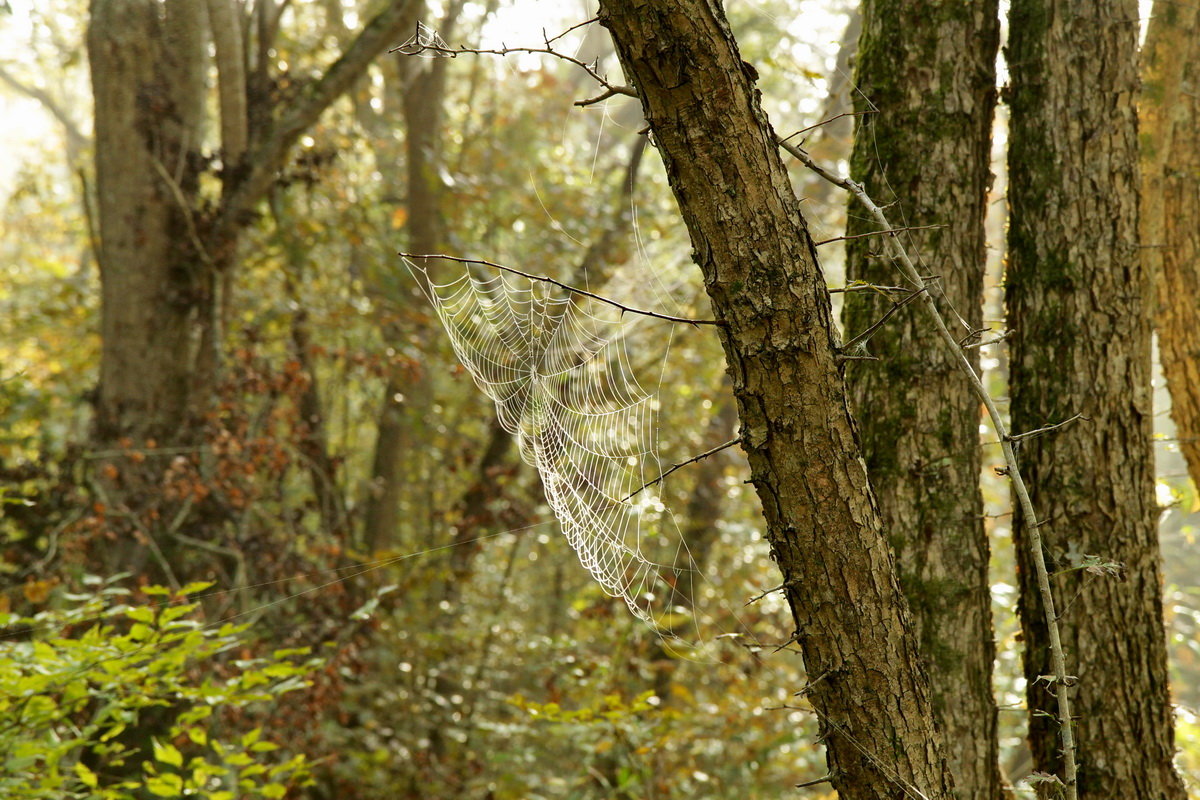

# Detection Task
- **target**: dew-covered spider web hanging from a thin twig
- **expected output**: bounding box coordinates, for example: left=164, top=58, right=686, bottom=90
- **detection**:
left=404, top=259, right=697, bottom=630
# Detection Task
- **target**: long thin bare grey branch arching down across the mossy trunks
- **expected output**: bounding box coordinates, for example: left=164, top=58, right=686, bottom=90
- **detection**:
left=778, top=139, right=1079, bottom=800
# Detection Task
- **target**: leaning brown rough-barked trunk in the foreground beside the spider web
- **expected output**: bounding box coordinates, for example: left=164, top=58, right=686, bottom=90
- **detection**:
left=600, top=0, right=952, bottom=800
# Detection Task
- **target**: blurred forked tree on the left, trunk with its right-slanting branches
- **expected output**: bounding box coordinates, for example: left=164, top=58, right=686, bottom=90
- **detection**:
left=88, top=0, right=415, bottom=444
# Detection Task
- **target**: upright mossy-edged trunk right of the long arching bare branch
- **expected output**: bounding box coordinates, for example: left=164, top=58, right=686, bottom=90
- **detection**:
left=1007, top=0, right=1184, bottom=800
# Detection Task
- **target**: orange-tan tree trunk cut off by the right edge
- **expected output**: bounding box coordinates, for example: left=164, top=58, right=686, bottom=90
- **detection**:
left=1139, top=0, right=1200, bottom=487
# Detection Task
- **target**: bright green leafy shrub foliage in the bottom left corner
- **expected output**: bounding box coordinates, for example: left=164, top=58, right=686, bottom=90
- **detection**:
left=0, top=581, right=319, bottom=800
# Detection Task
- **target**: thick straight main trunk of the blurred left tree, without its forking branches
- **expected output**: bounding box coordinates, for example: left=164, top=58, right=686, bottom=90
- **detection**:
left=88, top=0, right=214, bottom=445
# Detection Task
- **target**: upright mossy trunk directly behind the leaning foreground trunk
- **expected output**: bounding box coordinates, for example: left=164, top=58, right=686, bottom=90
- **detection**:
left=842, top=0, right=1003, bottom=800
